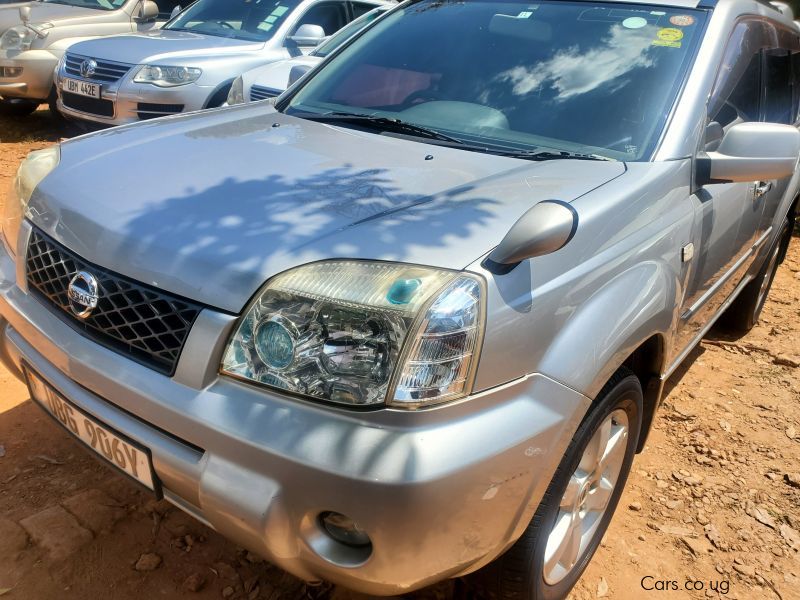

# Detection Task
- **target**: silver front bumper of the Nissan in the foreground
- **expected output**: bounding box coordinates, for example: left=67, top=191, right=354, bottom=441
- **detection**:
left=0, top=224, right=589, bottom=595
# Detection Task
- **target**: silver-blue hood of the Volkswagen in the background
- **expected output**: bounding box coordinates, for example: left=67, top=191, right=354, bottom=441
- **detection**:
left=70, top=30, right=264, bottom=64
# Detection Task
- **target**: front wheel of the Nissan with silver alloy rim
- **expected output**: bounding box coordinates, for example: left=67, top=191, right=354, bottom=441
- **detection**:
left=473, top=368, right=642, bottom=600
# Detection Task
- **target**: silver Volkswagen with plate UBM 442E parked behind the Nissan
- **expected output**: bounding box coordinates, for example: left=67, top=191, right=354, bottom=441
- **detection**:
left=57, top=0, right=388, bottom=125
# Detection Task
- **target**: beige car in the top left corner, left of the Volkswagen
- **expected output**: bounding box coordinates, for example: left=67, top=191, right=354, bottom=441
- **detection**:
left=0, top=0, right=180, bottom=115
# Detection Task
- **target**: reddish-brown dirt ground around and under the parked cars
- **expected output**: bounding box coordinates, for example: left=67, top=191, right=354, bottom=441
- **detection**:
left=0, top=110, right=800, bottom=600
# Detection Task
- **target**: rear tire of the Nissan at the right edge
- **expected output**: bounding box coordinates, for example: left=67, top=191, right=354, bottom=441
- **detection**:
left=720, top=220, right=792, bottom=334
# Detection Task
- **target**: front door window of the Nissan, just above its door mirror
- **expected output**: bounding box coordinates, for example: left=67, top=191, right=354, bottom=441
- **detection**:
left=706, top=21, right=764, bottom=139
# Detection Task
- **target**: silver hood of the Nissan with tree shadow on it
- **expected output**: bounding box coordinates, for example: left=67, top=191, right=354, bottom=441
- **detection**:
left=29, top=105, right=625, bottom=312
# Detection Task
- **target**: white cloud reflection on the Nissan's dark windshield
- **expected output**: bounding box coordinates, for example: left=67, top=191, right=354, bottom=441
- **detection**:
left=496, top=25, right=656, bottom=102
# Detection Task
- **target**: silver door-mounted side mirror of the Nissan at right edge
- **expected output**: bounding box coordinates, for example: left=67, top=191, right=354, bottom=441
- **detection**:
left=695, top=123, right=800, bottom=185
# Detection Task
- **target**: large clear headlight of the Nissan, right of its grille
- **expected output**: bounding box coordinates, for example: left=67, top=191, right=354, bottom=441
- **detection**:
left=222, top=261, right=484, bottom=408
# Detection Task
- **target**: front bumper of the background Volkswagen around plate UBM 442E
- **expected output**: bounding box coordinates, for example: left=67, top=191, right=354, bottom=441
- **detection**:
left=56, top=67, right=216, bottom=125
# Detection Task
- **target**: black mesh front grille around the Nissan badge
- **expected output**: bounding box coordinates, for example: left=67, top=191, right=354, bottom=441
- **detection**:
left=26, top=229, right=203, bottom=375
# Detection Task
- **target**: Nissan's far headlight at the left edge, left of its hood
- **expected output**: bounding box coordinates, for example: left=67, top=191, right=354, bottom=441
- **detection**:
left=2, top=145, right=61, bottom=254
